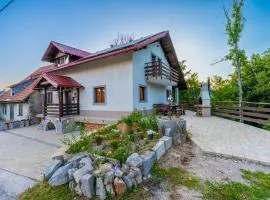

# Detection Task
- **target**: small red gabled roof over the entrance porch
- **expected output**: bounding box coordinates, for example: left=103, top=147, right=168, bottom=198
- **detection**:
left=32, top=73, right=83, bottom=89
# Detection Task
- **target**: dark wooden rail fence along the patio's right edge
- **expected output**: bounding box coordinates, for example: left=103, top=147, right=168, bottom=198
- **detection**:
left=211, top=101, right=270, bottom=126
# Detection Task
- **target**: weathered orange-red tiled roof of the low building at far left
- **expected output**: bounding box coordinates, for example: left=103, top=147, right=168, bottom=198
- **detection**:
left=0, top=81, right=36, bottom=102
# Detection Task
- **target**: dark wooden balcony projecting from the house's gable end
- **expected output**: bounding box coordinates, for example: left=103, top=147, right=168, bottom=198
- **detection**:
left=145, top=61, right=179, bottom=86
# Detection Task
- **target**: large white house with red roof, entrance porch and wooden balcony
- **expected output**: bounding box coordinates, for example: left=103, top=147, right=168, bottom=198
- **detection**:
left=0, top=31, right=186, bottom=132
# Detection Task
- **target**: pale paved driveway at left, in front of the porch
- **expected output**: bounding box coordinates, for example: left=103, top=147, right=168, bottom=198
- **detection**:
left=0, top=126, right=67, bottom=200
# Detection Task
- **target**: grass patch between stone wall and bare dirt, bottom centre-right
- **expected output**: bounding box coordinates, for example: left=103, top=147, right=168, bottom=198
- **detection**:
left=152, top=163, right=201, bottom=189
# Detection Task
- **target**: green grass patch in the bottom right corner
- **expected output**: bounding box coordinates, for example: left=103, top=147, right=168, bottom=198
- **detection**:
left=202, top=170, right=270, bottom=200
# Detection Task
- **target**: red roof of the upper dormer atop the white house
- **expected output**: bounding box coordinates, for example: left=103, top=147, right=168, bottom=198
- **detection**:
left=41, top=41, right=90, bottom=61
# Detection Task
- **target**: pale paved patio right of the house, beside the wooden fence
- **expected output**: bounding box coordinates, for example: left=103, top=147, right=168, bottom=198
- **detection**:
left=183, top=111, right=270, bottom=165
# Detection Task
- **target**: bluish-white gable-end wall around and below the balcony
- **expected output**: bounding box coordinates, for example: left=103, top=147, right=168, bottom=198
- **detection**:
left=132, top=42, right=171, bottom=110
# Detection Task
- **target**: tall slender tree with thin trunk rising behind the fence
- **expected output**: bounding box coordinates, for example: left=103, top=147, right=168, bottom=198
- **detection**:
left=224, top=0, right=245, bottom=122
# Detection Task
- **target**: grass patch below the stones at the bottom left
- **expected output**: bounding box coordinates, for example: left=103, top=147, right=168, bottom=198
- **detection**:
left=18, top=182, right=79, bottom=200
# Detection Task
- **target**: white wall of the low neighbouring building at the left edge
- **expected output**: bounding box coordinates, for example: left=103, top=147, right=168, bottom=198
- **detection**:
left=0, top=103, right=29, bottom=121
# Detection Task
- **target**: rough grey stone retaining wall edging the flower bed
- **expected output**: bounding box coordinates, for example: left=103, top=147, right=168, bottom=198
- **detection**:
left=44, top=120, right=186, bottom=199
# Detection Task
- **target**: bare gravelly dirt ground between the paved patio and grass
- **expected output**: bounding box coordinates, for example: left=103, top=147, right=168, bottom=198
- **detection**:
left=149, top=141, right=270, bottom=200
